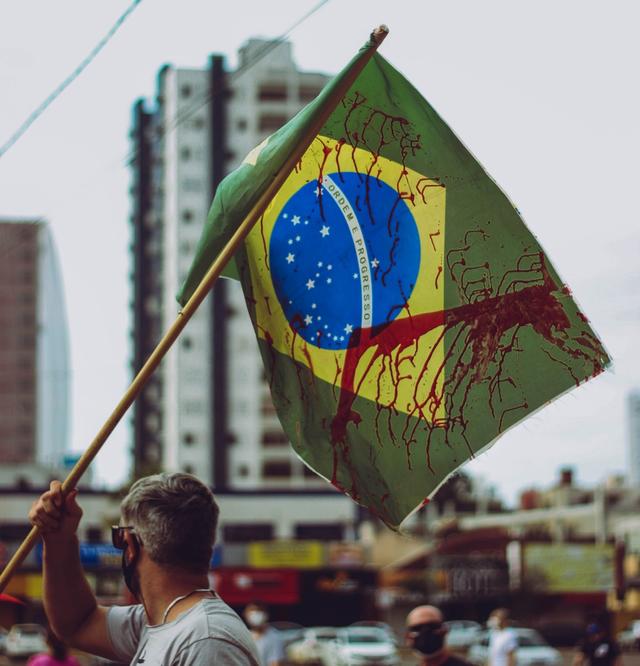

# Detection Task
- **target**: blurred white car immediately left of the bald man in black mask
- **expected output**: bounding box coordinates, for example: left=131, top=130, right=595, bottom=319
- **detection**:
left=325, top=627, right=400, bottom=666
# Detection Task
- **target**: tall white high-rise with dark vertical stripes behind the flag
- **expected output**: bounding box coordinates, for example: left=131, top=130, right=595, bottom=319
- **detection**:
left=131, top=39, right=327, bottom=491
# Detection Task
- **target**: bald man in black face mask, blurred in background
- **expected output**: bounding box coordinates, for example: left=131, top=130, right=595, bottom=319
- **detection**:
left=406, top=606, right=471, bottom=666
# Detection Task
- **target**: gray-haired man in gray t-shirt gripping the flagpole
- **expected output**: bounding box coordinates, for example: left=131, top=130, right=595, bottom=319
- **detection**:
left=29, top=473, right=260, bottom=666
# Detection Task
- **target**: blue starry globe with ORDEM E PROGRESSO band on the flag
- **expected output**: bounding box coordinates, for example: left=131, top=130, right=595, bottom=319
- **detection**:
left=269, top=172, right=420, bottom=349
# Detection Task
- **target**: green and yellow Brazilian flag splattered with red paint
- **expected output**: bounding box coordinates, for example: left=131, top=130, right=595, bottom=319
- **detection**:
left=179, top=36, right=609, bottom=528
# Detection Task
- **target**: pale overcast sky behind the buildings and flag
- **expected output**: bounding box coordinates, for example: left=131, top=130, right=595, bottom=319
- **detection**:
left=0, top=0, right=640, bottom=499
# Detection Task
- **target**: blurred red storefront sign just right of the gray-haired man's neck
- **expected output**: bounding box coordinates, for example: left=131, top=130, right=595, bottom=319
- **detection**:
left=209, top=567, right=300, bottom=606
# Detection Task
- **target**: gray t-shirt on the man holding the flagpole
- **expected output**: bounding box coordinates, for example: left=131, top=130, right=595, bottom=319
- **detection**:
left=107, top=598, right=259, bottom=666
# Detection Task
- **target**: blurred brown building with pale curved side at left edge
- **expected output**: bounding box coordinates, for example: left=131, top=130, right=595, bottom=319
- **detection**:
left=0, top=219, right=70, bottom=485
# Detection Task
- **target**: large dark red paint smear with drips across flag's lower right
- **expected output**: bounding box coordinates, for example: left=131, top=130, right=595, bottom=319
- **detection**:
left=331, top=254, right=602, bottom=488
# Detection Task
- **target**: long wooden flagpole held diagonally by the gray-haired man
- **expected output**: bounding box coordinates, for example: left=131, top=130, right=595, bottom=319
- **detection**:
left=0, top=25, right=389, bottom=592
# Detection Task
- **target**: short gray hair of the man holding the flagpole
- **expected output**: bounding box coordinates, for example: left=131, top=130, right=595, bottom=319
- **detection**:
left=120, top=472, right=220, bottom=573
